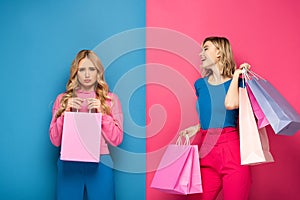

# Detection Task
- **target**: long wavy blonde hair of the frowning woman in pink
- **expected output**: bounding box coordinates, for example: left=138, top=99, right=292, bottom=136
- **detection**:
left=56, top=50, right=111, bottom=117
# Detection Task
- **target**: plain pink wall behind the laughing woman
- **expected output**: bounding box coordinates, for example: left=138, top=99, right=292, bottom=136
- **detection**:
left=146, top=0, right=300, bottom=200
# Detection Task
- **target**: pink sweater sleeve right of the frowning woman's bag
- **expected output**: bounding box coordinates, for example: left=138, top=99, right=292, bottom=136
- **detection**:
left=102, top=93, right=123, bottom=146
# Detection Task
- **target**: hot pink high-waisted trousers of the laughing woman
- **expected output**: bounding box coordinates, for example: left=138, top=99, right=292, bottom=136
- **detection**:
left=187, top=127, right=251, bottom=200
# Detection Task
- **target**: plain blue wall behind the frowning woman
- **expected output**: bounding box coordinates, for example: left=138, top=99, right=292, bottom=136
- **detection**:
left=0, top=0, right=145, bottom=200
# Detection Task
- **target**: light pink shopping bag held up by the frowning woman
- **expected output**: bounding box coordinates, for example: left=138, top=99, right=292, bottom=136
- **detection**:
left=60, top=112, right=102, bottom=162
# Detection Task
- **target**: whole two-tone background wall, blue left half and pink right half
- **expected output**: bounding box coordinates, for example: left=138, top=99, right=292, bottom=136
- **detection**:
left=0, top=0, right=300, bottom=200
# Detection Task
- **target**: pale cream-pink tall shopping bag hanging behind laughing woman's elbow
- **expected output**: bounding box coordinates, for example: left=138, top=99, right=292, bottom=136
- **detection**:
left=239, top=88, right=273, bottom=165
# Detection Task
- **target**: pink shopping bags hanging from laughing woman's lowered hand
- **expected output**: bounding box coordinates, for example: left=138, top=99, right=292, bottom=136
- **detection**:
left=151, top=136, right=202, bottom=195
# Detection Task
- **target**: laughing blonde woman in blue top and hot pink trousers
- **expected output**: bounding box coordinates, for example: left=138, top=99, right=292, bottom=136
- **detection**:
left=180, top=37, right=251, bottom=200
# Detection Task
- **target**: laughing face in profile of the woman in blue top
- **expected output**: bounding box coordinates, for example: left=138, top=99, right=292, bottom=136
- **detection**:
left=200, top=41, right=219, bottom=68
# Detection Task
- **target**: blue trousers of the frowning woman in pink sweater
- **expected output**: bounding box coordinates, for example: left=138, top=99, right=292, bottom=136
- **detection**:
left=57, top=155, right=115, bottom=200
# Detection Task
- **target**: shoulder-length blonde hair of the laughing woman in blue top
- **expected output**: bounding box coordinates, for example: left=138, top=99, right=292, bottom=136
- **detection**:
left=202, top=37, right=236, bottom=78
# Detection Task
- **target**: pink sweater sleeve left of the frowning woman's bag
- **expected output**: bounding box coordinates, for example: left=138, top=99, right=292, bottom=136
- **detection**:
left=49, top=94, right=64, bottom=147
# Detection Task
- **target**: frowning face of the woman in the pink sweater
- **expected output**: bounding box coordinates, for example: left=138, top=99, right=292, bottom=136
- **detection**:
left=77, top=58, right=98, bottom=91
